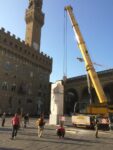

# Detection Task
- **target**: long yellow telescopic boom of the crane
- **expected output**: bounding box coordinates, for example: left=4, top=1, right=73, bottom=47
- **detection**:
left=65, top=6, right=107, bottom=103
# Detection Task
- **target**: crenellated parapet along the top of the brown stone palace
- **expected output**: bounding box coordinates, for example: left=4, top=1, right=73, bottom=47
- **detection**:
left=0, top=28, right=52, bottom=72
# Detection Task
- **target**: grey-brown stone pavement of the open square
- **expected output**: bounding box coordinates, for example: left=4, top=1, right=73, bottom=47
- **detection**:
left=0, top=119, right=113, bottom=150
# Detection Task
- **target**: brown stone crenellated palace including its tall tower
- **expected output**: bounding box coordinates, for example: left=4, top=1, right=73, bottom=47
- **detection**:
left=0, top=0, right=52, bottom=115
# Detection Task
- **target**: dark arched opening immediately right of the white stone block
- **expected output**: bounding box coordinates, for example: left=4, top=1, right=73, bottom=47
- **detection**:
left=64, top=89, right=78, bottom=115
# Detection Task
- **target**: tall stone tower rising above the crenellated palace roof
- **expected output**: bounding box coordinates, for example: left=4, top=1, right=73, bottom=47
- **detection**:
left=25, top=0, right=44, bottom=51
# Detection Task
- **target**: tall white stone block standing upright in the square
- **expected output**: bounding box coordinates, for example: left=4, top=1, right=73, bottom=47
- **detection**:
left=49, top=81, right=64, bottom=125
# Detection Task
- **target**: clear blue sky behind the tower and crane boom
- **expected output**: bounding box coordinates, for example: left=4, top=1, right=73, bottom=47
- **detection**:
left=0, top=0, right=113, bottom=82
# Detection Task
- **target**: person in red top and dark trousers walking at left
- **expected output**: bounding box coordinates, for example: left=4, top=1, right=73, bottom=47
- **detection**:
left=12, top=113, right=20, bottom=140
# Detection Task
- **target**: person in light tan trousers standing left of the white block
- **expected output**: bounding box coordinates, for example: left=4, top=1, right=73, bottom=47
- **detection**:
left=36, top=115, right=45, bottom=137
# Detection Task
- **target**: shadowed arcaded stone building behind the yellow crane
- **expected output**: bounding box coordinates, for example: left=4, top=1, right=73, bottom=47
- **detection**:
left=64, top=69, right=113, bottom=114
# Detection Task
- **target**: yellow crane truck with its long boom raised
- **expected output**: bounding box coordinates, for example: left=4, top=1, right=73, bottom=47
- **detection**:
left=65, top=6, right=113, bottom=126
